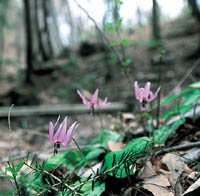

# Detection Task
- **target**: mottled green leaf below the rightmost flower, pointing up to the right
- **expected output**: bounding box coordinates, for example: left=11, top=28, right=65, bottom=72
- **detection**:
left=153, top=119, right=185, bottom=144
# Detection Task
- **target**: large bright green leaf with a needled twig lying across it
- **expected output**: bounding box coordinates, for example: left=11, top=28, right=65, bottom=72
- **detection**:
left=101, top=137, right=152, bottom=178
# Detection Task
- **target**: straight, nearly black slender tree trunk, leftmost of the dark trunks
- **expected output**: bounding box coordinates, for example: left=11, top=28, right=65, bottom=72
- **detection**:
left=24, top=0, right=33, bottom=84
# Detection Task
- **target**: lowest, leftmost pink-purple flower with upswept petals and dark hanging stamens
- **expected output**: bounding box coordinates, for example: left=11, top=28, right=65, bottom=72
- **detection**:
left=49, top=116, right=79, bottom=154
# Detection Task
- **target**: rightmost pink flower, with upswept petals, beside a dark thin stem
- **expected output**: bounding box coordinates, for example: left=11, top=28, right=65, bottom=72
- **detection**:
left=135, top=81, right=160, bottom=111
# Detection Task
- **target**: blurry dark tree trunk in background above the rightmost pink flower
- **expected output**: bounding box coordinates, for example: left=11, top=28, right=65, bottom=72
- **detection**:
left=152, top=0, right=161, bottom=40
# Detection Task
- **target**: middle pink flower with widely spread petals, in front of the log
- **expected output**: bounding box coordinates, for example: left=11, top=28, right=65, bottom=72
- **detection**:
left=77, top=88, right=111, bottom=115
